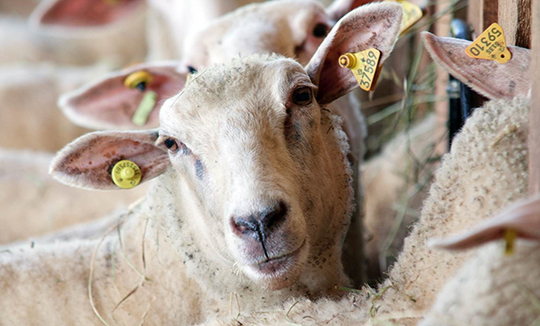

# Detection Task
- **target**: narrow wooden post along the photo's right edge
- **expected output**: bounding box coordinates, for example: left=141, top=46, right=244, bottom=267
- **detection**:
left=529, top=1, right=540, bottom=195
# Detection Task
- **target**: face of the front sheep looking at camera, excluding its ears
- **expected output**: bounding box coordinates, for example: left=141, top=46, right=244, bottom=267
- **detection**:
left=157, top=57, right=349, bottom=289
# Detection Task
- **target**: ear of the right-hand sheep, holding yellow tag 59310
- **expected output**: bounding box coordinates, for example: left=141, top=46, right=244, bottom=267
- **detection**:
left=422, top=32, right=531, bottom=99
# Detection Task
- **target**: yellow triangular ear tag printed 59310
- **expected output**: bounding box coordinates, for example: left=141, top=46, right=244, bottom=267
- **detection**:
left=465, top=23, right=512, bottom=63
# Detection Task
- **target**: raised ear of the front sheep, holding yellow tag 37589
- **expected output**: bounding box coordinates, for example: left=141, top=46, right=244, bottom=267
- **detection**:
left=306, top=2, right=402, bottom=104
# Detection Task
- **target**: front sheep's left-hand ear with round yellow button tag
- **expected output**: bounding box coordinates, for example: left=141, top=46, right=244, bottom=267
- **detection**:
left=49, top=130, right=170, bottom=189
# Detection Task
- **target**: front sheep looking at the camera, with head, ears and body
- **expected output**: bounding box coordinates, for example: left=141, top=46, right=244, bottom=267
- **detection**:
left=0, top=4, right=401, bottom=325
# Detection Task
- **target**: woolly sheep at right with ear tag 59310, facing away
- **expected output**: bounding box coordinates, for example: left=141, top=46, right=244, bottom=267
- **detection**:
left=189, top=33, right=532, bottom=325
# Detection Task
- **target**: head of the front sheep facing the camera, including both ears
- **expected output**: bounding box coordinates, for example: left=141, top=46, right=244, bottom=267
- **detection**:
left=51, top=4, right=401, bottom=289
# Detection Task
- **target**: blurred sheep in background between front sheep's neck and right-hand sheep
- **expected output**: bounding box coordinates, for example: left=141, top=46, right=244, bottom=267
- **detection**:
left=361, top=114, right=443, bottom=281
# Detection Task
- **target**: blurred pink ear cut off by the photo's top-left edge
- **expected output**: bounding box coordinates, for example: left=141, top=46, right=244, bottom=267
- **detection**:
left=39, top=0, right=142, bottom=27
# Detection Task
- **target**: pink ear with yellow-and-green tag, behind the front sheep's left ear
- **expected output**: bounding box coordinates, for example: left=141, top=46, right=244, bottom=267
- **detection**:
left=58, top=62, right=189, bottom=129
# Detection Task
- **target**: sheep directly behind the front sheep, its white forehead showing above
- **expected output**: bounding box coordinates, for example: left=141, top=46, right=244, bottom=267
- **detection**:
left=59, top=0, right=401, bottom=284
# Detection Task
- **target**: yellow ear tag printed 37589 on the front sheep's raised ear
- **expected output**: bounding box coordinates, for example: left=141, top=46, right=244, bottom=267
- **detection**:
left=339, top=49, right=381, bottom=91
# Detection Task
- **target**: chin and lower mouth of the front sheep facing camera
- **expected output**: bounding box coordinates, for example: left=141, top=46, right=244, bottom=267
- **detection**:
left=241, top=242, right=309, bottom=290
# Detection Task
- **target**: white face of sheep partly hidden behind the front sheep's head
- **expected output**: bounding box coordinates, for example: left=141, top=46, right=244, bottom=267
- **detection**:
left=183, top=0, right=335, bottom=69
